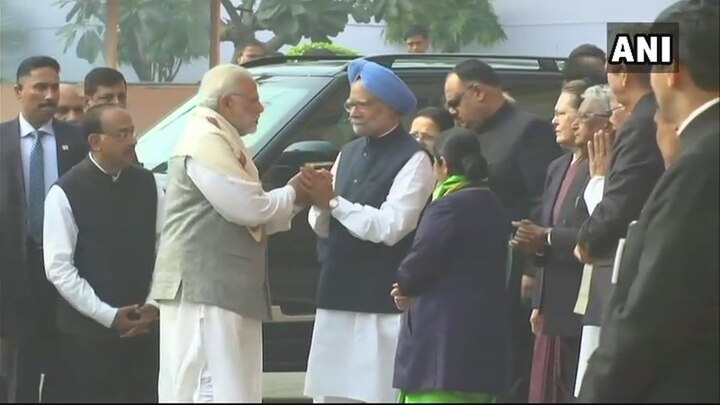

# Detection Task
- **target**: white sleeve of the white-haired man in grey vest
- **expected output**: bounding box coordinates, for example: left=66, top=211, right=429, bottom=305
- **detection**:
left=187, top=158, right=302, bottom=235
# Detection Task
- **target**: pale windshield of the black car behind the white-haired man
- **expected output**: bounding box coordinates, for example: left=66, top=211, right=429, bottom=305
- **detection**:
left=136, top=76, right=328, bottom=173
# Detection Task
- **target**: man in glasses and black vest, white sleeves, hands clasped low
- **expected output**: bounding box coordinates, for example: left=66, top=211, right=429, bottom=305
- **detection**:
left=44, top=104, right=164, bottom=403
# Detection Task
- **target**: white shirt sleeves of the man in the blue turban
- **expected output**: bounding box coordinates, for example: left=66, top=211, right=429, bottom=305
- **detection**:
left=308, top=151, right=435, bottom=246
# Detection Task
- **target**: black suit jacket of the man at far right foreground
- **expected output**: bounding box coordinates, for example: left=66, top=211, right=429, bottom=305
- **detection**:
left=580, top=104, right=720, bottom=403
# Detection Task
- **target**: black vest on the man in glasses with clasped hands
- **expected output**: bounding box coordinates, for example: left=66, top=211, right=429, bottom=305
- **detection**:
left=57, top=158, right=157, bottom=338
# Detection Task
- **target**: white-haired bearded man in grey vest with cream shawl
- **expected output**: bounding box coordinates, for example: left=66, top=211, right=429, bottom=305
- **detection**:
left=150, top=65, right=304, bottom=402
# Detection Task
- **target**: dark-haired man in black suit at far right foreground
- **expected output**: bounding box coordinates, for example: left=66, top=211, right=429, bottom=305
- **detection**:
left=580, top=0, right=720, bottom=403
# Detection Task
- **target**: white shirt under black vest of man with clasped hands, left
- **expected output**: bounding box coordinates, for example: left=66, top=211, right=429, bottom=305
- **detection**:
left=43, top=155, right=165, bottom=328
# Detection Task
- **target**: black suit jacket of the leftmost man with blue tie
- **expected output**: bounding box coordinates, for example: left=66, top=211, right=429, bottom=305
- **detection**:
left=0, top=119, right=88, bottom=338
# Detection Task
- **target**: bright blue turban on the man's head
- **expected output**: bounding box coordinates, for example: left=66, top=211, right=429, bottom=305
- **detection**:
left=348, top=59, right=417, bottom=115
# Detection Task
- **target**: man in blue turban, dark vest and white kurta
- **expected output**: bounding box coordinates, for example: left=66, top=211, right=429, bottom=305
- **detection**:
left=305, top=59, right=435, bottom=402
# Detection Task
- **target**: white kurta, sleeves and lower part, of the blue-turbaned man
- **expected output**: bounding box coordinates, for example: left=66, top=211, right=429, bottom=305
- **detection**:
left=304, top=145, right=435, bottom=402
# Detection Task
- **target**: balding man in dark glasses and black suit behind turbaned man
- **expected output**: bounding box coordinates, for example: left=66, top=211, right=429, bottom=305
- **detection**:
left=445, top=59, right=562, bottom=402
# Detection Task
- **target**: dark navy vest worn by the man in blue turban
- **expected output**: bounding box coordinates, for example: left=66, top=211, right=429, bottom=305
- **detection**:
left=317, top=127, right=422, bottom=313
